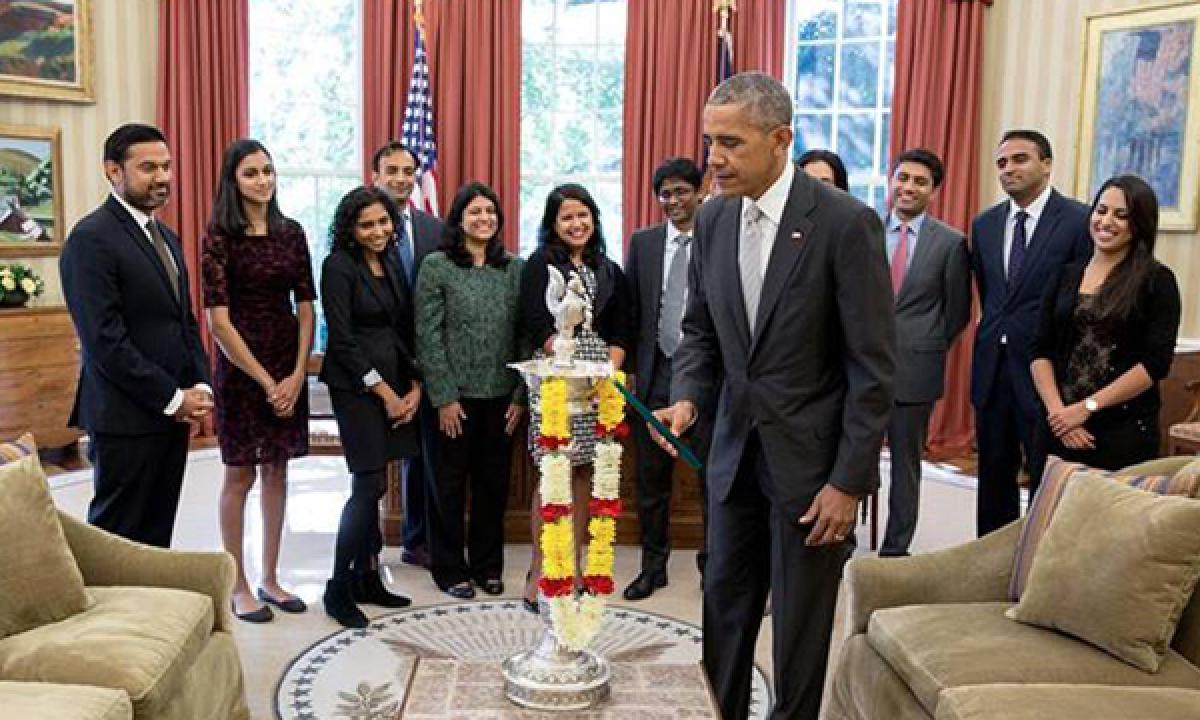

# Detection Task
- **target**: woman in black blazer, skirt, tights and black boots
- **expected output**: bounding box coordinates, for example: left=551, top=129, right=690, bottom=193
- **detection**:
left=320, top=187, right=421, bottom=628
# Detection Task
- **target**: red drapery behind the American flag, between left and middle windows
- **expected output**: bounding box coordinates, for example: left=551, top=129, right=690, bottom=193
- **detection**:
left=362, top=0, right=521, bottom=250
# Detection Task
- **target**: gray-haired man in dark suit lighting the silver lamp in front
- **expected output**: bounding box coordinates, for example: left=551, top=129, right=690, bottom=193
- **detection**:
left=658, top=72, right=895, bottom=720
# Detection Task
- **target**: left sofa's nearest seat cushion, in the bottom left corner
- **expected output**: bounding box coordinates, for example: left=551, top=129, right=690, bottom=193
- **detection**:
left=0, top=682, right=133, bottom=720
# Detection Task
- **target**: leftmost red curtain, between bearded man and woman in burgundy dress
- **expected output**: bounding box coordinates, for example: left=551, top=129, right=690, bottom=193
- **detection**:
left=157, top=0, right=250, bottom=356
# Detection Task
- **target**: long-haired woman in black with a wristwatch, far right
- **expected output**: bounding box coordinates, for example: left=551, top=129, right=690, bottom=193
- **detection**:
left=1031, top=175, right=1180, bottom=470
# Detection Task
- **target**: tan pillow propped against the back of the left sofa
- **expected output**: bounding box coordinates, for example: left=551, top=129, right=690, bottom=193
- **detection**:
left=0, top=452, right=88, bottom=638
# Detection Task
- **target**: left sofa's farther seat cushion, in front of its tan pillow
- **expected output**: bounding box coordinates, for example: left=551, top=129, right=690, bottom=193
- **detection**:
left=0, top=587, right=212, bottom=716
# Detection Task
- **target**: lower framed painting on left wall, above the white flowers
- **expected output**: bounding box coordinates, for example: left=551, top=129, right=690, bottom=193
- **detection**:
left=0, top=125, right=65, bottom=257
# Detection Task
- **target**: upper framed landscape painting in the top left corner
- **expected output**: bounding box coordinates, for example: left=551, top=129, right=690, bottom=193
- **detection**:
left=0, top=0, right=96, bottom=102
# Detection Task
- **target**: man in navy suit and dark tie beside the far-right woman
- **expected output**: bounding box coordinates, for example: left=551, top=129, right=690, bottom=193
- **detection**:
left=971, top=130, right=1092, bottom=535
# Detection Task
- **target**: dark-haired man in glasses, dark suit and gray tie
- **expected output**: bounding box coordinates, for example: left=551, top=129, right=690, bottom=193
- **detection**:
left=625, top=157, right=704, bottom=600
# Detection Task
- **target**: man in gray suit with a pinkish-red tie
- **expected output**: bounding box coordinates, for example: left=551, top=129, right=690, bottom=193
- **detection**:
left=880, top=149, right=971, bottom=557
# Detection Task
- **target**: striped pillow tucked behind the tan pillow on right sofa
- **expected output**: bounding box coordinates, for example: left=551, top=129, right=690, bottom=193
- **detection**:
left=1008, top=455, right=1200, bottom=602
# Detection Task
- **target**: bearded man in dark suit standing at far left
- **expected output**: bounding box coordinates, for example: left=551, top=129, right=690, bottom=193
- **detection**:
left=59, top=124, right=212, bottom=547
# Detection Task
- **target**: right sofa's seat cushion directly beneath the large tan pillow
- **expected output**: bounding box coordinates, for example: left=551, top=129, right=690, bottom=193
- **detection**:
left=866, top=602, right=1200, bottom=715
